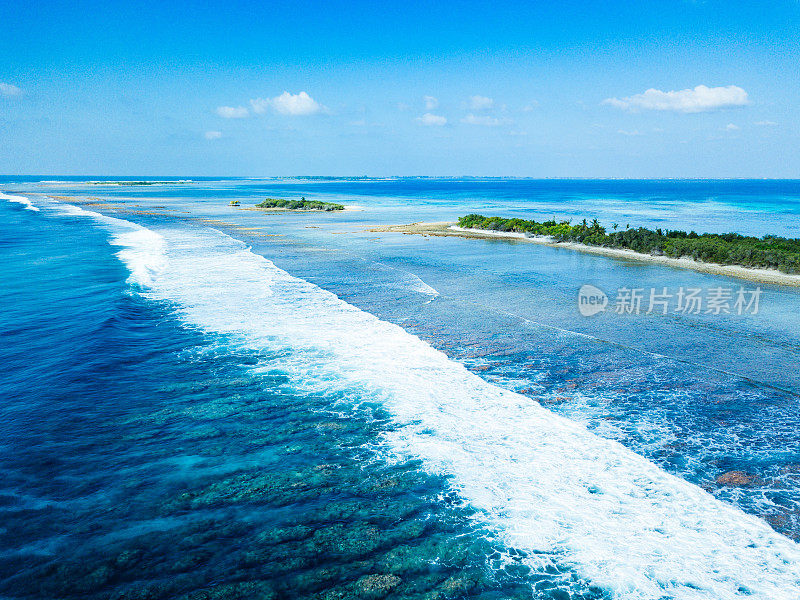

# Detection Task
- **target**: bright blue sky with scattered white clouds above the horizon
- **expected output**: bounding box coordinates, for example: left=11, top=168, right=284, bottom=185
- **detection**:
left=0, top=0, right=800, bottom=177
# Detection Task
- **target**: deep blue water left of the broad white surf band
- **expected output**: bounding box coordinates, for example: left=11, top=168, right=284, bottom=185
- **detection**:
left=0, top=195, right=598, bottom=598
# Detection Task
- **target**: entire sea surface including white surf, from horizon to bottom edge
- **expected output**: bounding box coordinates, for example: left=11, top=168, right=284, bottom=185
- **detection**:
left=0, top=177, right=800, bottom=598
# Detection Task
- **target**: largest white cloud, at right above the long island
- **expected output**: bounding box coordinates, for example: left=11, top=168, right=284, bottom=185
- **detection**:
left=603, top=85, right=750, bottom=113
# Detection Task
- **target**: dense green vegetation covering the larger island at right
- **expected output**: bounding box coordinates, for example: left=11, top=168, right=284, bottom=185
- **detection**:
left=458, top=214, right=800, bottom=273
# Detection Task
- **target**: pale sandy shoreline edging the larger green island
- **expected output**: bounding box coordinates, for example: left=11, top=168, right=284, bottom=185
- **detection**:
left=369, top=222, right=800, bottom=287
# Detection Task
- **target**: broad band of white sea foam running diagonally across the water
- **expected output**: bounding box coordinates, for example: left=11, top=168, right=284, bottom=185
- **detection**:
left=45, top=211, right=800, bottom=600
